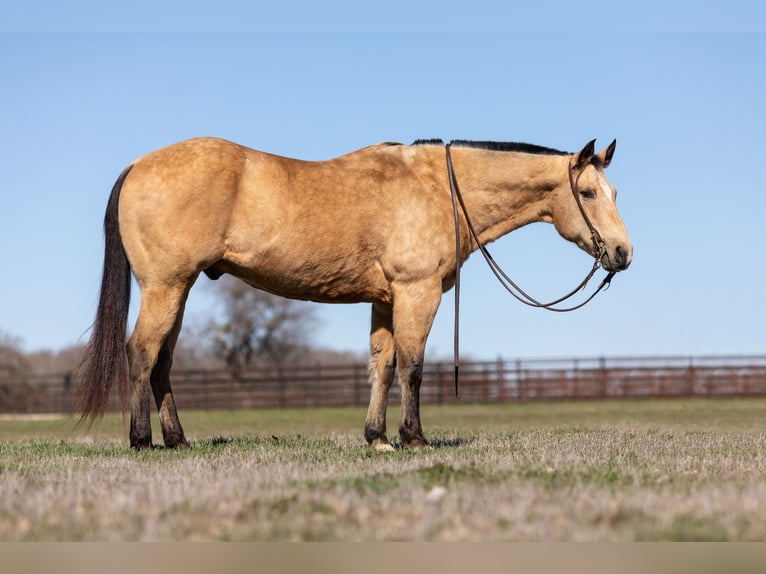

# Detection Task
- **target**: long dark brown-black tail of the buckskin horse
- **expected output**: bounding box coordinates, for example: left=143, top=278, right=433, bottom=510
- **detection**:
left=74, top=165, right=133, bottom=424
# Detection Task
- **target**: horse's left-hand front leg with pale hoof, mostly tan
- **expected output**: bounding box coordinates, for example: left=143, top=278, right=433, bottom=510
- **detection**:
left=364, top=304, right=396, bottom=450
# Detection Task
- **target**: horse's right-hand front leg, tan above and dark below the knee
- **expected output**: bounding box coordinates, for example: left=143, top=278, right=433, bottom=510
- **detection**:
left=394, top=277, right=441, bottom=448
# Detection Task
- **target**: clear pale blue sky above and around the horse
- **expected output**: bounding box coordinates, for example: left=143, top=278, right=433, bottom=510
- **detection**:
left=0, top=2, right=766, bottom=359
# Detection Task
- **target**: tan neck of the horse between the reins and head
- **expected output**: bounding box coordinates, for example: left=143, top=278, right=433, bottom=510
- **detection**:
left=453, top=149, right=569, bottom=243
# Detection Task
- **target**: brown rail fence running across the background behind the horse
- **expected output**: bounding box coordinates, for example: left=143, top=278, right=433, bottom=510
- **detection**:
left=0, top=355, right=766, bottom=413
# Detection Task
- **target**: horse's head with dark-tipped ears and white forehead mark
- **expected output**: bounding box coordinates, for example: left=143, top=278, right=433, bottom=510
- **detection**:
left=552, top=140, right=633, bottom=271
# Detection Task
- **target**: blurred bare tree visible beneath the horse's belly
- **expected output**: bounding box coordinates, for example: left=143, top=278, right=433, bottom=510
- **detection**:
left=208, top=276, right=315, bottom=370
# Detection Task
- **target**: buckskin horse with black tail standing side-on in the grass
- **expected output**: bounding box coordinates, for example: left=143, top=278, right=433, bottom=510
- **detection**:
left=74, top=137, right=633, bottom=451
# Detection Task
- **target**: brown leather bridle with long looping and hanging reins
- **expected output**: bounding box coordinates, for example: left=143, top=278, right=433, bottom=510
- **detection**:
left=445, top=143, right=615, bottom=397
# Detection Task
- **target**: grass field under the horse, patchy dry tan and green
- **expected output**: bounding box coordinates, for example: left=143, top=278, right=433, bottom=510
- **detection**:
left=0, top=399, right=766, bottom=541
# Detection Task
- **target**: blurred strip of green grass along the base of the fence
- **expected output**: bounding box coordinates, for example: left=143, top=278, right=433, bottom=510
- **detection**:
left=0, top=399, right=766, bottom=441
